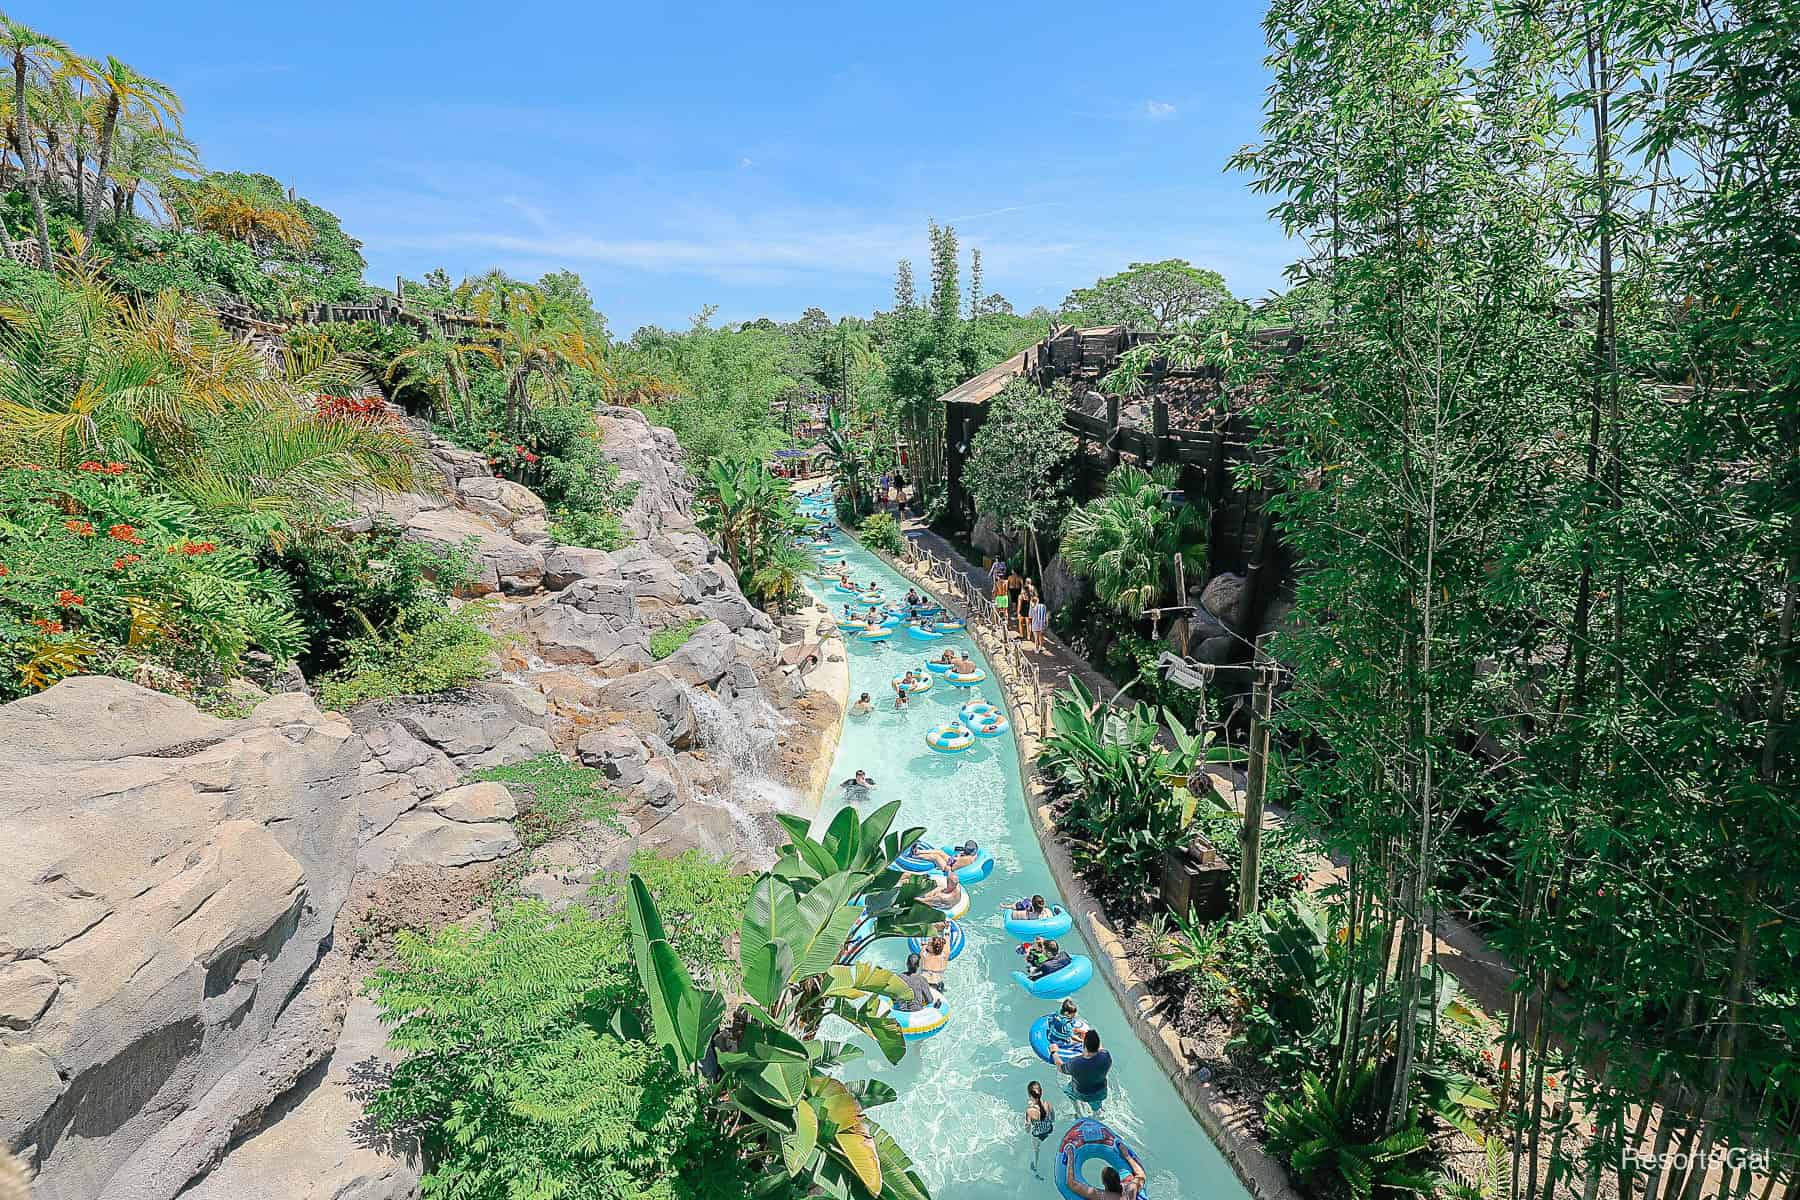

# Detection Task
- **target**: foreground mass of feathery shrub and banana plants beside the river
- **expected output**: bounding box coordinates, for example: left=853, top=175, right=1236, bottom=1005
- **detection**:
left=371, top=802, right=940, bottom=1200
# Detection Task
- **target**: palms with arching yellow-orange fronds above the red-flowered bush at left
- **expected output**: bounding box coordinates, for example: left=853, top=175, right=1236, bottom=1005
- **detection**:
left=0, top=251, right=421, bottom=525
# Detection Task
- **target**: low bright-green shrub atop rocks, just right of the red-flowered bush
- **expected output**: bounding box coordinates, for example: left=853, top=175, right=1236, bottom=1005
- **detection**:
left=319, top=601, right=499, bottom=709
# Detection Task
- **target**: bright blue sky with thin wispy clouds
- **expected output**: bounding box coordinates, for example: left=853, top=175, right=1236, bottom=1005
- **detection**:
left=31, top=0, right=1292, bottom=335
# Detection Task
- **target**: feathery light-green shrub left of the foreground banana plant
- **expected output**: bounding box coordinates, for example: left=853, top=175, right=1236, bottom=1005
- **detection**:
left=369, top=855, right=766, bottom=1200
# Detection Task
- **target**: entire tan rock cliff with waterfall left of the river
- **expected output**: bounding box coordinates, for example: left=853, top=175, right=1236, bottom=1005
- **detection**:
left=0, top=408, right=835, bottom=1200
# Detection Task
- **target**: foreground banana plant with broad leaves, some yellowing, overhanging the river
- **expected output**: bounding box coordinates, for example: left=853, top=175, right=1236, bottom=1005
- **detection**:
left=626, top=802, right=943, bottom=1200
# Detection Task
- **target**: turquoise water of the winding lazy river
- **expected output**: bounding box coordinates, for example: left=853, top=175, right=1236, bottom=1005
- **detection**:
left=808, top=492, right=1246, bottom=1200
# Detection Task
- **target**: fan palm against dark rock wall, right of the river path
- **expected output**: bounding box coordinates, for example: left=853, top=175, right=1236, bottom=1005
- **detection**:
left=1062, top=464, right=1206, bottom=617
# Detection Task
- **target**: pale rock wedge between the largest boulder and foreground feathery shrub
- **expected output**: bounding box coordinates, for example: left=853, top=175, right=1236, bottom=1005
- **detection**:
left=182, top=997, right=421, bottom=1200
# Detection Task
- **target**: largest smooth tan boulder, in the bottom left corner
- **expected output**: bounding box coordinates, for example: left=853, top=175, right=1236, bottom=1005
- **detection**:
left=0, top=676, right=365, bottom=1200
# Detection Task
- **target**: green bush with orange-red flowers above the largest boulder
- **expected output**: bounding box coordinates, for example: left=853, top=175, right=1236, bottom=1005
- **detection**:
left=0, top=461, right=304, bottom=702
